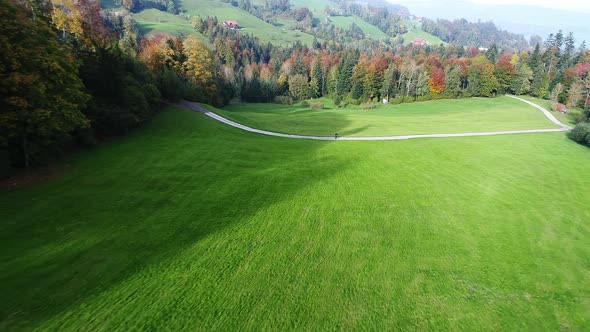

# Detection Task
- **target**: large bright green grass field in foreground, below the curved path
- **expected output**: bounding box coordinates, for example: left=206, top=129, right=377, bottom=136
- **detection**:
left=0, top=108, right=590, bottom=331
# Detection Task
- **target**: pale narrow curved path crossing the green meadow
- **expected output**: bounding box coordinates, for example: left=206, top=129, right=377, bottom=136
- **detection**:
left=180, top=96, right=572, bottom=141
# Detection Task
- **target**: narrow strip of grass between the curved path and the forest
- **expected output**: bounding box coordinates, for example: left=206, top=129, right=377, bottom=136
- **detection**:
left=215, top=96, right=557, bottom=136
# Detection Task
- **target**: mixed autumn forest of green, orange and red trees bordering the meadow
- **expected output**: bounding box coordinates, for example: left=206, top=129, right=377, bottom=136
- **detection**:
left=0, top=0, right=590, bottom=169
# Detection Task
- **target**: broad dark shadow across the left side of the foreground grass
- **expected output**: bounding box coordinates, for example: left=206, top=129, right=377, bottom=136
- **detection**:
left=0, top=106, right=354, bottom=330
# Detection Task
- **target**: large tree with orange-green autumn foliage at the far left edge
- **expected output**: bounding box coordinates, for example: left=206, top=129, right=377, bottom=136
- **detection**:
left=0, top=1, right=89, bottom=167
